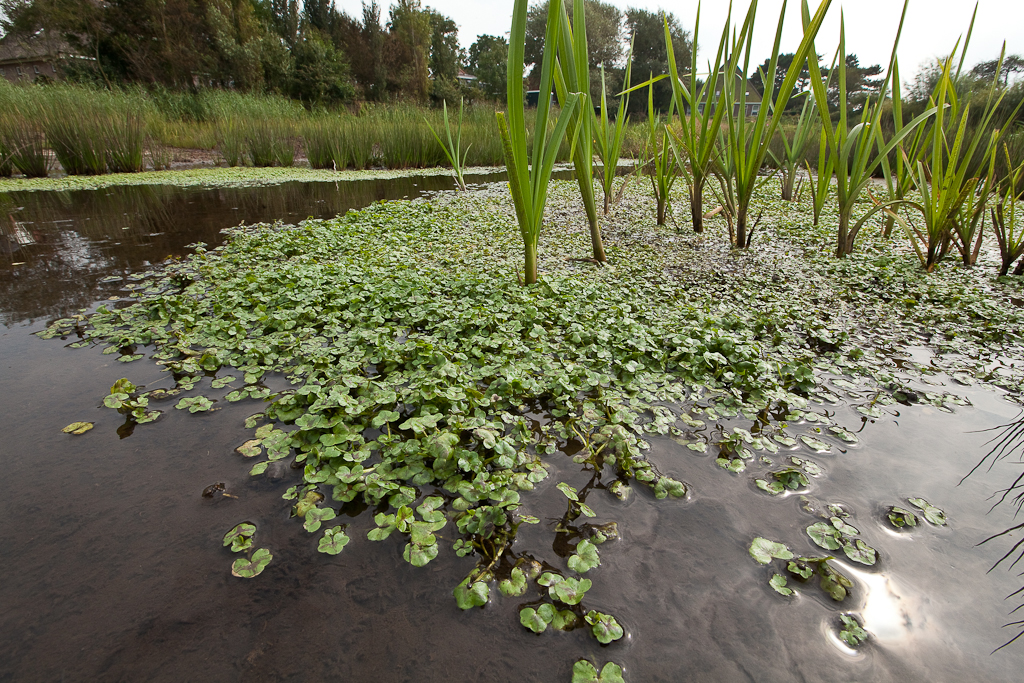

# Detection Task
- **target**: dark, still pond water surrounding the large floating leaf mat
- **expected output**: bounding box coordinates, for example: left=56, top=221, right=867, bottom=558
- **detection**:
left=0, top=177, right=1024, bottom=683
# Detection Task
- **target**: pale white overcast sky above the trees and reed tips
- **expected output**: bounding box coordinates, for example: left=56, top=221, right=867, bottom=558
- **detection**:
left=335, top=0, right=1024, bottom=81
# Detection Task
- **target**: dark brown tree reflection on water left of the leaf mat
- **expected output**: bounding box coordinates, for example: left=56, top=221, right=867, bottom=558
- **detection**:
left=0, top=173, right=528, bottom=327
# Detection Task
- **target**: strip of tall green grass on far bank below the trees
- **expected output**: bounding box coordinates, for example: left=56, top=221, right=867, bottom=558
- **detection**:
left=0, top=81, right=639, bottom=177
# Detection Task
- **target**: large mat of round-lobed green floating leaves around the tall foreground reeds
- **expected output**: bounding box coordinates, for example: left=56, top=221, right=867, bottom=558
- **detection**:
left=42, top=182, right=1024, bottom=680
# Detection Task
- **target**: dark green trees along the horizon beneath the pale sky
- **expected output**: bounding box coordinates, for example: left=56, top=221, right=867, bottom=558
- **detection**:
left=0, top=0, right=1024, bottom=119
